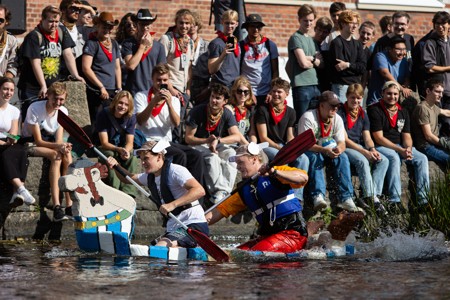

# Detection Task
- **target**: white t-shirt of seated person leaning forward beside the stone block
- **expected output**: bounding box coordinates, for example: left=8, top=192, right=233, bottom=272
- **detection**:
left=22, top=101, right=69, bottom=137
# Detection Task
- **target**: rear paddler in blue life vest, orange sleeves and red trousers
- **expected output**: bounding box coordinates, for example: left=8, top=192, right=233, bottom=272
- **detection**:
left=206, top=142, right=308, bottom=253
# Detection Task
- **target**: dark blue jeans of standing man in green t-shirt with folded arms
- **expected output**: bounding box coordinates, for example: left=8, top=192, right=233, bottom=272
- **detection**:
left=292, top=85, right=320, bottom=122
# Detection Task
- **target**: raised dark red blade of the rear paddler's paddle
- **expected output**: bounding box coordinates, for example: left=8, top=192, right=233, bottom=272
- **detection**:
left=269, top=129, right=316, bottom=167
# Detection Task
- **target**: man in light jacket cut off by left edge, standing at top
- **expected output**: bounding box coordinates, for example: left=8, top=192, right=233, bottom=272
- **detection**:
left=0, top=5, right=17, bottom=78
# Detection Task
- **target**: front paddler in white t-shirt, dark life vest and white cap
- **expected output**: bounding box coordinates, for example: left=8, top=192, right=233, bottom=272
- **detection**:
left=108, top=140, right=209, bottom=248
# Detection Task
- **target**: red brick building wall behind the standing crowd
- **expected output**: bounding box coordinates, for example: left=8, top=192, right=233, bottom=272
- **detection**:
left=19, top=0, right=450, bottom=52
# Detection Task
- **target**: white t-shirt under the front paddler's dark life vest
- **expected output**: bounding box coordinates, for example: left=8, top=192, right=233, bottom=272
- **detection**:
left=138, top=164, right=206, bottom=232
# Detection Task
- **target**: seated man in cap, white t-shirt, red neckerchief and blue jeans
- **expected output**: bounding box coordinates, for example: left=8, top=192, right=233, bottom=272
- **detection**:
left=298, top=91, right=362, bottom=212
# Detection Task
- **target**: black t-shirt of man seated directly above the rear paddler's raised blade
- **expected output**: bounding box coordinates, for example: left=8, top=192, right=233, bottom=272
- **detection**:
left=255, top=105, right=296, bottom=144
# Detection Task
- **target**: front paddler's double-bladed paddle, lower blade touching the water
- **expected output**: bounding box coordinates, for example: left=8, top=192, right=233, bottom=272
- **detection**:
left=58, top=111, right=229, bottom=262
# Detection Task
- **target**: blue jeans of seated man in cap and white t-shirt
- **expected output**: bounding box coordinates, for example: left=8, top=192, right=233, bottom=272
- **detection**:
left=306, top=151, right=353, bottom=202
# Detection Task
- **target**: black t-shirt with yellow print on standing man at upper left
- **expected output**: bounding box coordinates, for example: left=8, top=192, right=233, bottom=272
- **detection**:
left=18, top=26, right=75, bottom=89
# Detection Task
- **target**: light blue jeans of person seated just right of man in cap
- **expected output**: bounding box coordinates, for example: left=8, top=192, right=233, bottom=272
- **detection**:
left=345, top=146, right=389, bottom=197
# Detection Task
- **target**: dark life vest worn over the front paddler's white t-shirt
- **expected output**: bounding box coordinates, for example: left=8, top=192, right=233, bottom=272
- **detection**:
left=147, top=158, right=199, bottom=216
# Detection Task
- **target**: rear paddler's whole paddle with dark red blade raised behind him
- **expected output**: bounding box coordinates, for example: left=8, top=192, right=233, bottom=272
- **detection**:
left=205, top=129, right=316, bottom=214
